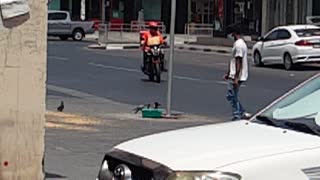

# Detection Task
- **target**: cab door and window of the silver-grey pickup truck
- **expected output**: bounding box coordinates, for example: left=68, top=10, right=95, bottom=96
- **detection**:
left=48, top=12, right=71, bottom=35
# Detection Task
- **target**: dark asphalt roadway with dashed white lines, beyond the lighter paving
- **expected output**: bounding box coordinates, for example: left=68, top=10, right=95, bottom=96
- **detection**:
left=48, top=41, right=320, bottom=119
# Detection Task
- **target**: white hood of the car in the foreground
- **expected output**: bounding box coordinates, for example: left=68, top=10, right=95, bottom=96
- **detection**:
left=115, top=121, right=320, bottom=171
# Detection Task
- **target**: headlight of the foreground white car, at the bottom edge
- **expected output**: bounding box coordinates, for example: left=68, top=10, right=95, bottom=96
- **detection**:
left=167, top=172, right=241, bottom=180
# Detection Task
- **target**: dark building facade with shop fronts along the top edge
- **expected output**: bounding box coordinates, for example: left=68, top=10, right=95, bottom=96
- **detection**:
left=49, top=0, right=320, bottom=36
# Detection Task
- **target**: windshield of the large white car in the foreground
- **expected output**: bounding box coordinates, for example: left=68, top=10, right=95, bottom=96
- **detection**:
left=253, top=74, right=320, bottom=136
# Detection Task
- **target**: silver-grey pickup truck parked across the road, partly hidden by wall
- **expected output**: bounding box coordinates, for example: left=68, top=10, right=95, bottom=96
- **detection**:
left=48, top=11, right=95, bottom=41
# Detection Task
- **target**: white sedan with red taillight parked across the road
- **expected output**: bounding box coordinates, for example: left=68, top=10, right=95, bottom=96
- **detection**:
left=253, top=25, right=320, bottom=70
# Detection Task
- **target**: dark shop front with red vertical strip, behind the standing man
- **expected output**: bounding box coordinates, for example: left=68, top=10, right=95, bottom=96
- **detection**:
left=187, top=0, right=262, bottom=37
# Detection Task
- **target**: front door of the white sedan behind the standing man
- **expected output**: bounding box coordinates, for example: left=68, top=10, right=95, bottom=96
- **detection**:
left=261, top=30, right=278, bottom=61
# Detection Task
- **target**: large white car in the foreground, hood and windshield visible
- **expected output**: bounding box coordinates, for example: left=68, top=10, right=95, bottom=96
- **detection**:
left=96, top=74, right=320, bottom=180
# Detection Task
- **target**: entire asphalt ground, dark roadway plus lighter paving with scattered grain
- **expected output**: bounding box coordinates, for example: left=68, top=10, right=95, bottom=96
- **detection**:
left=45, top=41, right=320, bottom=180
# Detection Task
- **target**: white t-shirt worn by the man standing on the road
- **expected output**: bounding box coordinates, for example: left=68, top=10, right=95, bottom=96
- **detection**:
left=229, top=39, right=248, bottom=81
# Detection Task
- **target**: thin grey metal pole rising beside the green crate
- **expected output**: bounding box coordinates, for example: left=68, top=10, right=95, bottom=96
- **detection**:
left=167, top=0, right=176, bottom=117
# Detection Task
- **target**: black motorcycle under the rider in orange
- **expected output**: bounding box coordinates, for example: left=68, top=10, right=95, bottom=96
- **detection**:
left=143, top=45, right=164, bottom=83
